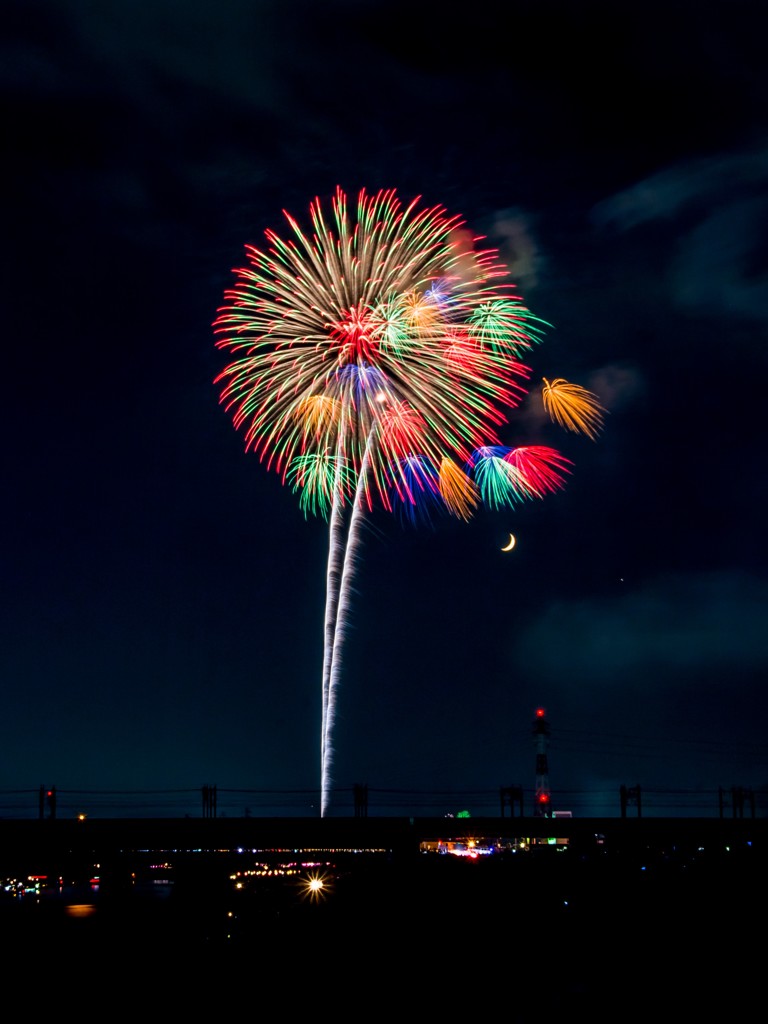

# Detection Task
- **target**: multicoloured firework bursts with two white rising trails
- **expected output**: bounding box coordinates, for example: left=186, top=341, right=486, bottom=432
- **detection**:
left=214, top=188, right=604, bottom=816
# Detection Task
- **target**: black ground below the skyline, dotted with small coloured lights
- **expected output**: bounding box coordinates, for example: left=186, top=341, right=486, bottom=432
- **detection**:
left=0, top=802, right=768, bottom=1011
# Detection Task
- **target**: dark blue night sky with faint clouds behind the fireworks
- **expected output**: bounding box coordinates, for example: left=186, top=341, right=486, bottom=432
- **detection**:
left=0, top=0, right=768, bottom=815
